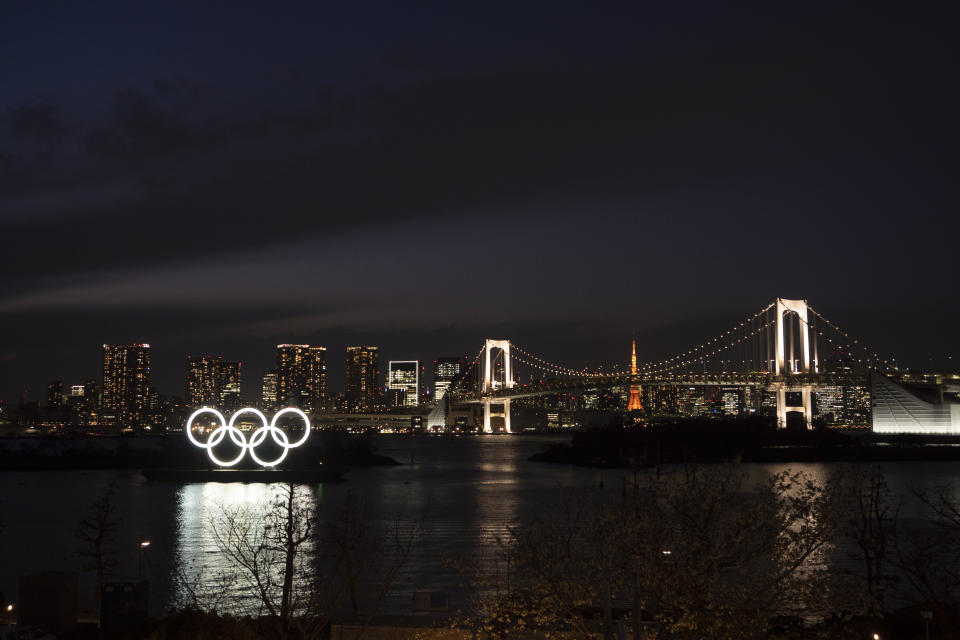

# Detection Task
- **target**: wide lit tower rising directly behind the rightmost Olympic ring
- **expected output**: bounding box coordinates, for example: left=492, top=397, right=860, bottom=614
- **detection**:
left=277, top=344, right=327, bottom=411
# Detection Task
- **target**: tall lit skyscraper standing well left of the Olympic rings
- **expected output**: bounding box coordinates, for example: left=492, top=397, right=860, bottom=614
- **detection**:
left=103, top=344, right=150, bottom=428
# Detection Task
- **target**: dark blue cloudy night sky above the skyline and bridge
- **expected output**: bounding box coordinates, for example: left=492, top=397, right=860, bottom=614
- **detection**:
left=0, top=2, right=960, bottom=402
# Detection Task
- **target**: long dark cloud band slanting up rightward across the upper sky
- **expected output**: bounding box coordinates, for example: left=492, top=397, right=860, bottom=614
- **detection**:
left=1, top=7, right=951, bottom=288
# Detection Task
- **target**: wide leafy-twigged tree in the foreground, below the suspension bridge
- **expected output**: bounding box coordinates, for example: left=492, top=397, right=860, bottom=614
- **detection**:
left=458, top=465, right=856, bottom=639
